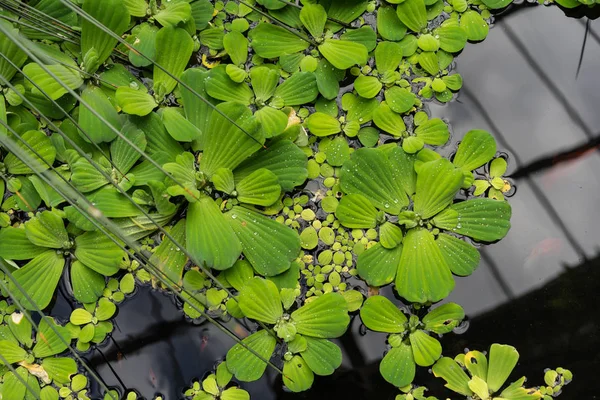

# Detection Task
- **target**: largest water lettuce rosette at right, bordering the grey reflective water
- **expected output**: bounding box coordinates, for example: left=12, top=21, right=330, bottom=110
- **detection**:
left=336, top=142, right=511, bottom=303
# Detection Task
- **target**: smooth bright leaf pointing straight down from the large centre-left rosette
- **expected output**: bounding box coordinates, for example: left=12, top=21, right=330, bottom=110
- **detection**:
left=186, top=196, right=242, bottom=270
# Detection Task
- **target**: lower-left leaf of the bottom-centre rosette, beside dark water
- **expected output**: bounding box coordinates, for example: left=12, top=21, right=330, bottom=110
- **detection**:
left=226, top=330, right=277, bottom=382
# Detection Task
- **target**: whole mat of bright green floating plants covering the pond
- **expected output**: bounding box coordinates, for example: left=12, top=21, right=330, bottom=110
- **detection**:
left=0, top=0, right=592, bottom=400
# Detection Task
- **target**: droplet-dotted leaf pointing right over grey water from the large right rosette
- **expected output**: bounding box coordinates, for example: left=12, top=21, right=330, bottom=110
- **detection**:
left=436, top=198, right=512, bottom=242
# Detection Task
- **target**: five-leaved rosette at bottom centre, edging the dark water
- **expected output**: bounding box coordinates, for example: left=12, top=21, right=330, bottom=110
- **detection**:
left=227, top=277, right=350, bottom=392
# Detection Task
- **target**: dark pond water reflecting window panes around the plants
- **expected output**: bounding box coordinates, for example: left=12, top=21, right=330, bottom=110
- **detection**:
left=55, top=6, right=600, bottom=400
